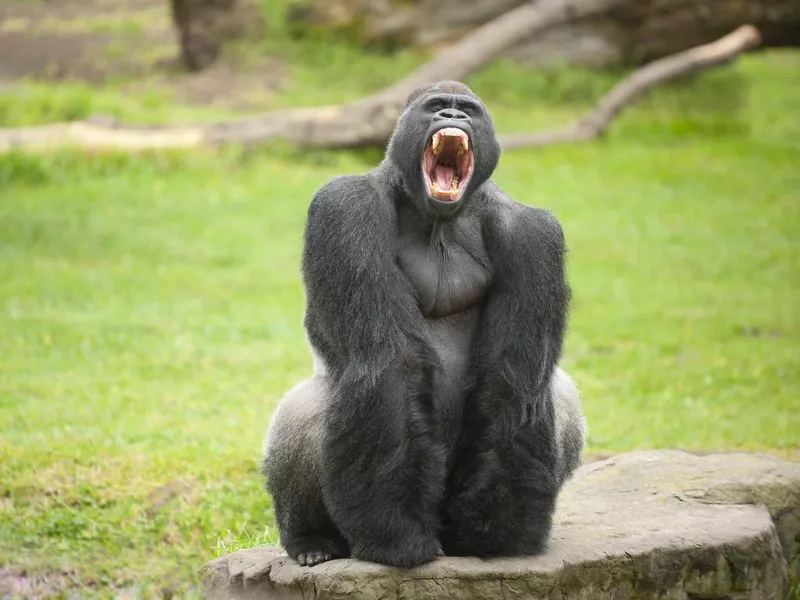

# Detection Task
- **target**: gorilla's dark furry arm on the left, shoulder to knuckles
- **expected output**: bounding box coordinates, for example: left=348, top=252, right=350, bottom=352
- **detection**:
left=303, top=176, right=445, bottom=566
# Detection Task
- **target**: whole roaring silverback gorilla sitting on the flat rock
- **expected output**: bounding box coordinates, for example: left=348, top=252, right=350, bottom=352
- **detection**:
left=264, top=81, right=584, bottom=567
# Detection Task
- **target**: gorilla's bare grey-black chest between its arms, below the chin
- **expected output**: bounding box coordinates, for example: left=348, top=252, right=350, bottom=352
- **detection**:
left=397, top=215, right=491, bottom=318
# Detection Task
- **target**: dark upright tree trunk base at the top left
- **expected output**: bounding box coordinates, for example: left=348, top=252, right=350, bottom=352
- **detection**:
left=170, top=0, right=261, bottom=71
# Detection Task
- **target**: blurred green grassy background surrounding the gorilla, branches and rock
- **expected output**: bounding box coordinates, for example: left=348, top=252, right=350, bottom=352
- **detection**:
left=0, top=0, right=800, bottom=598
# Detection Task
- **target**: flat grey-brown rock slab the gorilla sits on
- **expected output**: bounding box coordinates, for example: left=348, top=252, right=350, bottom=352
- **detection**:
left=203, top=450, right=800, bottom=600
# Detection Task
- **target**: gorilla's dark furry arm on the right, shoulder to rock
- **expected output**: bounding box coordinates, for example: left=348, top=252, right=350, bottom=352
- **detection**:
left=442, top=190, right=570, bottom=556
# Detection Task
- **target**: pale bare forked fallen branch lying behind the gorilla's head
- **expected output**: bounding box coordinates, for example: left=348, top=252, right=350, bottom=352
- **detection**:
left=0, top=22, right=760, bottom=152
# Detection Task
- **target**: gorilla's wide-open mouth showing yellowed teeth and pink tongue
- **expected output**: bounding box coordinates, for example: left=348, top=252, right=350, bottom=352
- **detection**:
left=422, top=127, right=472, bottom=202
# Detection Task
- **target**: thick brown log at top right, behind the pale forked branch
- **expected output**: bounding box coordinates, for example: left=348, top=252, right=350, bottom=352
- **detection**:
left=289, top=0, right=800, bottom=67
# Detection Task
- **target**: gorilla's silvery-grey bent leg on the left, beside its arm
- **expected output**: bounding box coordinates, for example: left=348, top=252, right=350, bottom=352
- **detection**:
left=264, top=375, right=350, bottom=566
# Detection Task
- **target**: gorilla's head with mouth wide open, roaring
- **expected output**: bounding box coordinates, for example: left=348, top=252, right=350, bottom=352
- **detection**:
left=386, top=81, right=500, bottom=217
